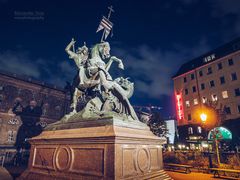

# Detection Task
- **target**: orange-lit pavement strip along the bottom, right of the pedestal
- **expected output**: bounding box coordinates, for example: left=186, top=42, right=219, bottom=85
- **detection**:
left=166, top=171, right=240, bottom=180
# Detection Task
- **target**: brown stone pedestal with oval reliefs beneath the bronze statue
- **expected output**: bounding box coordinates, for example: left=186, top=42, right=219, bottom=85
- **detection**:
left=19, top=118, right=170, bottom=180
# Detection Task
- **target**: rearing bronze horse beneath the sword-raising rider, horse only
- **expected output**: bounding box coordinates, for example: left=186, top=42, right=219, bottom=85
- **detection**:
left=71, top=42, right=124, bottom=112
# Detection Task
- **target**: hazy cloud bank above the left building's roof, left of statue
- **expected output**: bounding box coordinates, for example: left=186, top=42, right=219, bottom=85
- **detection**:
left=0, top=51, right=76, bottom=87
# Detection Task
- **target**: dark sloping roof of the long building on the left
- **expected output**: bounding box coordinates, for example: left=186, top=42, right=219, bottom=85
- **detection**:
left=0, top=70, right=65, bottom=92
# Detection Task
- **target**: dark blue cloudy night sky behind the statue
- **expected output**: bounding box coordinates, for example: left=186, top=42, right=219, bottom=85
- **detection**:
left=0, top=0, right=240, bottom=117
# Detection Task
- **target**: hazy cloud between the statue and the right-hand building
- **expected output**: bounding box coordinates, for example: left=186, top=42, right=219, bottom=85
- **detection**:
left=112, top=38, right=209, bottom=99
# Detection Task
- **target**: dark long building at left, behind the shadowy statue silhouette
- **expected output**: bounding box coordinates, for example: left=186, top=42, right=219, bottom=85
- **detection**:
left=0, top=72, right=70, bottom=152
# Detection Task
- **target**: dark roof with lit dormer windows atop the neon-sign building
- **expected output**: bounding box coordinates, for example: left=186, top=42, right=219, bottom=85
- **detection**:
left=172, top=37, right=240, bottom=78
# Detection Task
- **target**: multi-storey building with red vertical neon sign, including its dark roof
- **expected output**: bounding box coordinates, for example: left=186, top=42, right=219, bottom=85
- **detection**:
left=173, top=38, right=240, bottom=126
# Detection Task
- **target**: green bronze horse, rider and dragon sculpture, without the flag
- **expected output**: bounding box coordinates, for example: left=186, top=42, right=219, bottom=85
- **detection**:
left=66, top=40, right=138, bottom=120
